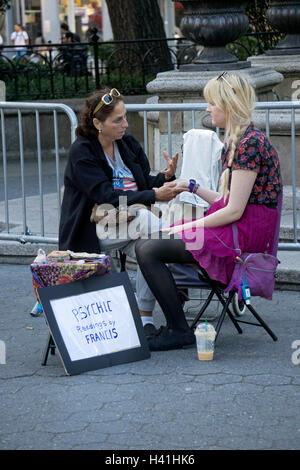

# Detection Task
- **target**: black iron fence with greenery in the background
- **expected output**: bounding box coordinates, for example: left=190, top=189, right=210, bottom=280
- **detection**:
left=0, top=32, right=280, bottom=101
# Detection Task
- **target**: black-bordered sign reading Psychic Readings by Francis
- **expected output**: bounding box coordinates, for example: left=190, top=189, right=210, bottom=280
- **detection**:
left=38, top=272, right=150, bottom=375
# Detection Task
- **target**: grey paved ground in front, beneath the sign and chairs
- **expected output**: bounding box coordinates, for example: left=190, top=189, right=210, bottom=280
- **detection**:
left=0, top=265, right=300, bottom=450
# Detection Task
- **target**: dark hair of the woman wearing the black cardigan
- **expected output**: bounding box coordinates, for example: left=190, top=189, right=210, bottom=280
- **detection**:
left=75, top=88, right=124, bottom=139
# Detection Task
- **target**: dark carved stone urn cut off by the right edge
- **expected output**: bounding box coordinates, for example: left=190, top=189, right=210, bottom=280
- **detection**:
left=266, top=0, right=300, bottom=55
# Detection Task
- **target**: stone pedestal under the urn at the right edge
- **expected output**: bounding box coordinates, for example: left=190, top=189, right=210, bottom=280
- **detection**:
left=248, top=50, right=300, bottom=101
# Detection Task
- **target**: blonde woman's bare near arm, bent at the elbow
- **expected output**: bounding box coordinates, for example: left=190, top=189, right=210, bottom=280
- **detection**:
left=164, top=170, right=257, bottom=234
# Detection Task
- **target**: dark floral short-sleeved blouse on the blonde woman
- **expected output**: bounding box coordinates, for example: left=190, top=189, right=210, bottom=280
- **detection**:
left=221, top=123, right=282, bottom=208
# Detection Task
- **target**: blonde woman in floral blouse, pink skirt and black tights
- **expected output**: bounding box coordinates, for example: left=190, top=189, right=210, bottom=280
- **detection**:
left=136, top=73, right=282, bottom=351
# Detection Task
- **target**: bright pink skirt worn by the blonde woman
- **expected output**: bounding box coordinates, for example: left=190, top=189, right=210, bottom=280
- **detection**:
left=178, top=198, right=278, bottom=285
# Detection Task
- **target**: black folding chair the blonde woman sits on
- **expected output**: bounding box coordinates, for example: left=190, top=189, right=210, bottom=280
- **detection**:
left=169, top=192, right=283, bottom=341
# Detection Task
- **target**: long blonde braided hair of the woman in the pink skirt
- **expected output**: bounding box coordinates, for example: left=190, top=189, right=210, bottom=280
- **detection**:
left=203, top=72, right=256, bottom=199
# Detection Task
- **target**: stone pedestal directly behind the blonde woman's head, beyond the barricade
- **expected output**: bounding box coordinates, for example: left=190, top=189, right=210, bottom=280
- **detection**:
left=147, top=67, right=283, bottom=175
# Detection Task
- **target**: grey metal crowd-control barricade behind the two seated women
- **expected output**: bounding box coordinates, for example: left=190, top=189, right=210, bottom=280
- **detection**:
left=0, top=101, right=300, bottom=250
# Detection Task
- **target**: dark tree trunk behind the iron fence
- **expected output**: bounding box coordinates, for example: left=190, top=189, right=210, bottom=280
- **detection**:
left=106, top=0, right=172, bottom=74
